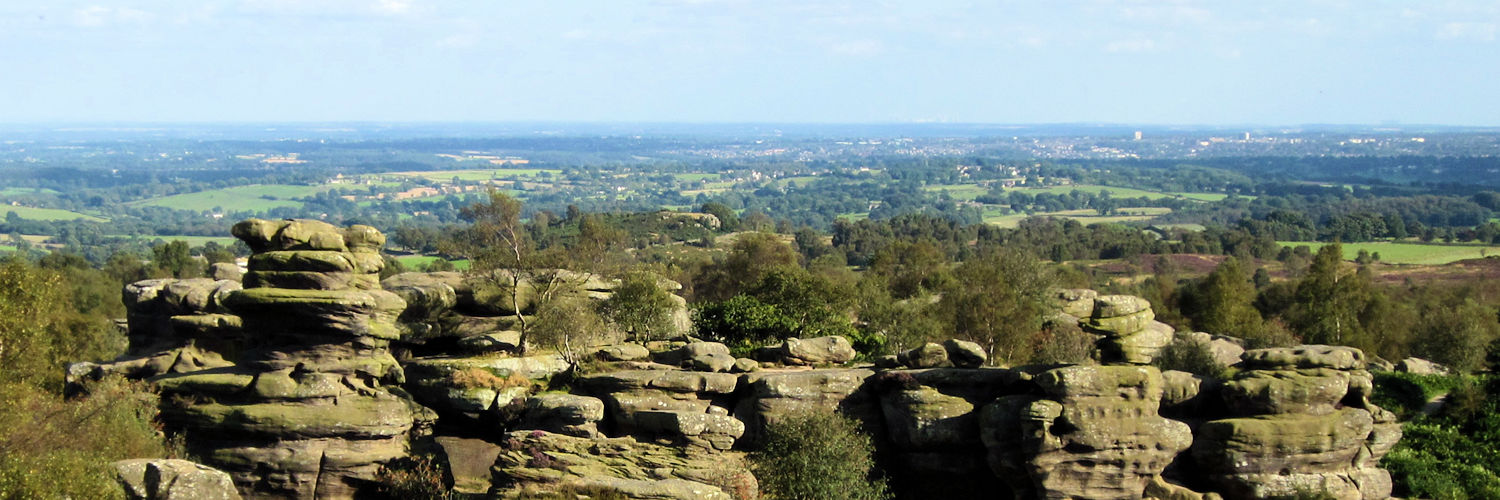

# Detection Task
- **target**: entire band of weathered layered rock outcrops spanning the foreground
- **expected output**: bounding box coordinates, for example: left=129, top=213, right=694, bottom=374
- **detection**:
left=69, top=244, right=1419, bottom=500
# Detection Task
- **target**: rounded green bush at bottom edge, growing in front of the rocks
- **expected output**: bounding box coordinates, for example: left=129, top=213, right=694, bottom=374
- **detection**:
left=750, top=413, right=890, bottom=500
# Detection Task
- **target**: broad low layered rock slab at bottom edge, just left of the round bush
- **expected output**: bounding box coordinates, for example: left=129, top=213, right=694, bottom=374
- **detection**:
left=491, top=431, right=759, bottom=500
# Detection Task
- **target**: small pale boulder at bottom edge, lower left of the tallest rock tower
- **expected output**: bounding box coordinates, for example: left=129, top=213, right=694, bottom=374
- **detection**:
left=110, top=458, right=240, bottom=500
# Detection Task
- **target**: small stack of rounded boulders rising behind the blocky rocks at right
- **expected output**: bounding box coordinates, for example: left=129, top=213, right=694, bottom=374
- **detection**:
left=1083, top=296, right=1173, bottom=365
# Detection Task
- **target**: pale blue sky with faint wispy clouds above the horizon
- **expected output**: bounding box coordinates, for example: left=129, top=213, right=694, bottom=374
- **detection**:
left=0, top=0, right=1500, bottom=126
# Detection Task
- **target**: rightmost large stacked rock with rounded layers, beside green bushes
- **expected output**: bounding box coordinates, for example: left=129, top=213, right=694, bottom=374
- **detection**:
left=1193, top=345, right=1401, bottom=498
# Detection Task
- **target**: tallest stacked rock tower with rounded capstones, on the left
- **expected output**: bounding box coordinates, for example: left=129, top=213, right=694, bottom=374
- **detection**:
left=158, top=219, right=417, bottom=498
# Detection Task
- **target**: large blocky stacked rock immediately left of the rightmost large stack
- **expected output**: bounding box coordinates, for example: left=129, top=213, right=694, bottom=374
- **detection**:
left=981, top=361, right=1193, bottom=498
